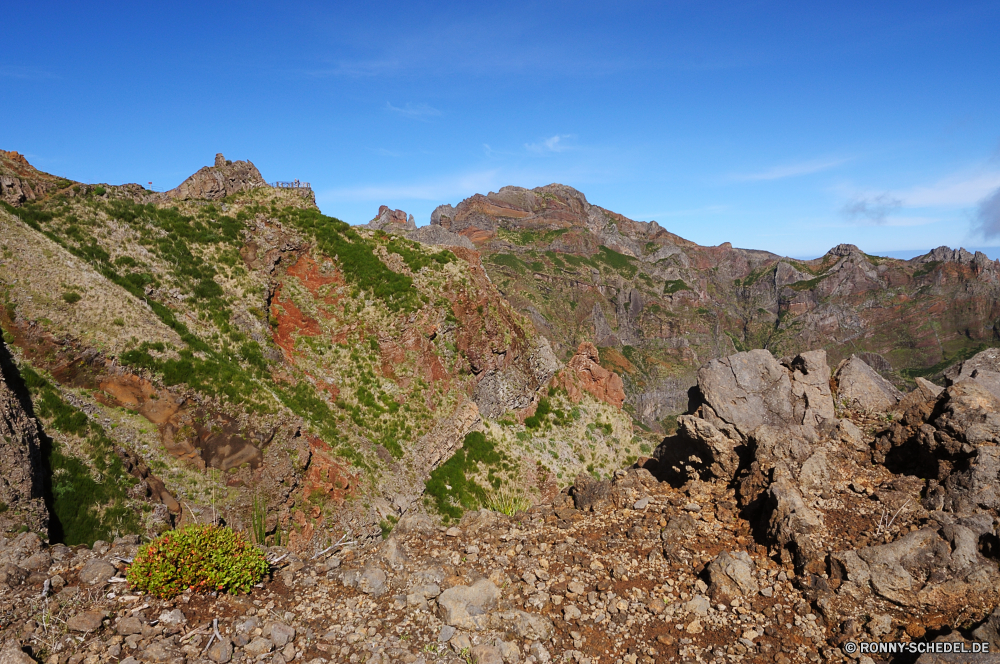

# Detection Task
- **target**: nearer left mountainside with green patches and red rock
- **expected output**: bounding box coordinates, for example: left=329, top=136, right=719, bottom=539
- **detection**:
left=0, top=155, right=659, bottom=546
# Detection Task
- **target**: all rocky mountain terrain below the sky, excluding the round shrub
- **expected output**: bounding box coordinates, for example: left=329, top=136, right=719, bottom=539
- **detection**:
left=0, top=153, right=1000, bottom=664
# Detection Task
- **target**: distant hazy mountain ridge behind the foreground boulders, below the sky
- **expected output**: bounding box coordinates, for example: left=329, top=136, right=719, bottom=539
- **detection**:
left=420, top=184, right=1000, bottom=430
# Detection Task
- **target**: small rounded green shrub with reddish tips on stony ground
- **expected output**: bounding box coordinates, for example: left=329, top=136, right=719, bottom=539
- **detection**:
left=126, top=524, right=268, bottom=599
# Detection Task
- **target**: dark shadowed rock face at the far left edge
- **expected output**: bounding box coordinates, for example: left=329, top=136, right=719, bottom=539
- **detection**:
left=0, top=342, right=49, bottom=535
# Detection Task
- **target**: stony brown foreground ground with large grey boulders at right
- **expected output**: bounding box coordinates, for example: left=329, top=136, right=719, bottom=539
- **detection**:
left=0, top=351, right=1000, bottom=664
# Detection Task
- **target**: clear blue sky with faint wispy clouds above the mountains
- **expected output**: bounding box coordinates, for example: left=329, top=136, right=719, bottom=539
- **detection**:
left=0, top=1, right=1000, bottom=257
